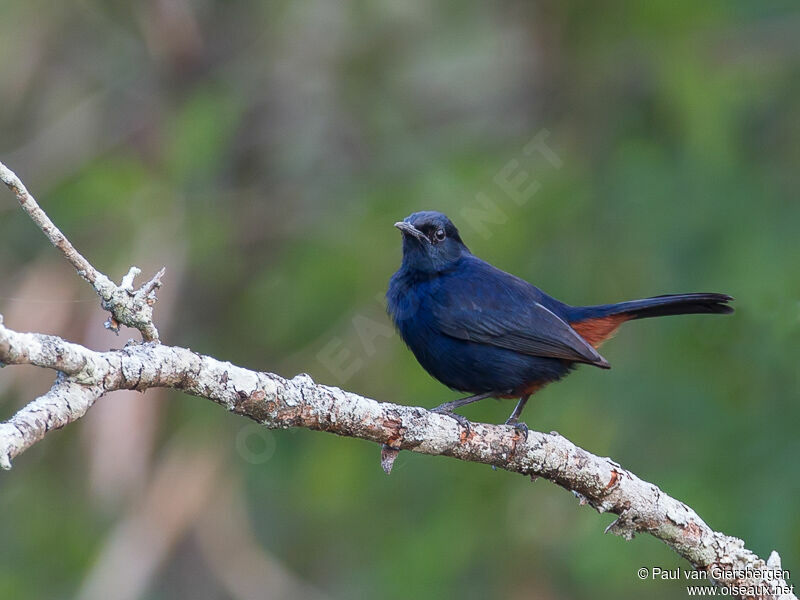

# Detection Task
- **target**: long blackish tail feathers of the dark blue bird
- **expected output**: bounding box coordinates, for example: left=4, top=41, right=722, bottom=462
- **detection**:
left=575, top=293, right=733, bottom=320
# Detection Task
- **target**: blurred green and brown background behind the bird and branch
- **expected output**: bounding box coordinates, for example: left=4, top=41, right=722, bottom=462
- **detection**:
left=0, top=0, right=800, bottom=600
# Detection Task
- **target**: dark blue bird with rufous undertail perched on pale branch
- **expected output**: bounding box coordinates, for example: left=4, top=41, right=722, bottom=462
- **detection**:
left=386, top=211, right=733, bottom=437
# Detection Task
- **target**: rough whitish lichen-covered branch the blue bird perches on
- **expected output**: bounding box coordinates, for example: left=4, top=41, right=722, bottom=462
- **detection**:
left=0, top=159, right=796, bottom=600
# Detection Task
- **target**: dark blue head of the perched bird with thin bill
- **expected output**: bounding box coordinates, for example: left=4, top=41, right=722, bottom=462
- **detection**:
left=394, top=210, right=469, bottom=273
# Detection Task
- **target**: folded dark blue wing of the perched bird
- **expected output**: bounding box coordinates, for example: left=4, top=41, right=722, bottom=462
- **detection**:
left=430, top=263, right=609, bottom=368
